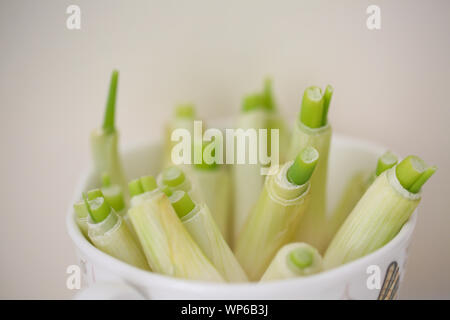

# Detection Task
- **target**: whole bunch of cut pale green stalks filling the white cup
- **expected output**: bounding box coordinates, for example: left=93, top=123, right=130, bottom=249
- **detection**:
left=74, top=71, right=436, bottom=282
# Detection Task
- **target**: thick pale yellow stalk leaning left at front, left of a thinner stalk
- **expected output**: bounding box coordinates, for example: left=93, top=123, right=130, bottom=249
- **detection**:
left=128, top=175, right=224, bottom=282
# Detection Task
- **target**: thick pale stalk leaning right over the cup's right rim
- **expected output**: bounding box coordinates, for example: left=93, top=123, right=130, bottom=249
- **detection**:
left=324, top=156, right=436, bottom=269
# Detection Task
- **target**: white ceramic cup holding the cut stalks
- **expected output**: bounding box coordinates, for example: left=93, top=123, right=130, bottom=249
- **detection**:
left=67, top=131, right=417, bottom=299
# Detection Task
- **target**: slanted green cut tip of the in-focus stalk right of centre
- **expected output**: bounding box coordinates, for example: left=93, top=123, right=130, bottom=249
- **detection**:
left=287, top=147, right=319, bottom=186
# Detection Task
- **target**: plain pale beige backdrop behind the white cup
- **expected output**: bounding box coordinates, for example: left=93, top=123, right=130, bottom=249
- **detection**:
left=0, top=0, right=450, bottom=298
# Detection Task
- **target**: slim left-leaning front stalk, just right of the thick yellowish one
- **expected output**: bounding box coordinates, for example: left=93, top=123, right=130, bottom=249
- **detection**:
left=169, top=191, right=248, bottom=282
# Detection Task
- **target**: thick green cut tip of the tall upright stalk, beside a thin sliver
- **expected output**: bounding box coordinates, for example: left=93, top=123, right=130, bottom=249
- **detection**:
left=300, top=86, right=324, bottom=128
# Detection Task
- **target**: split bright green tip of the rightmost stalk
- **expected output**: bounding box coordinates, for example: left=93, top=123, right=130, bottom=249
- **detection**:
left=395, top=156, right=437, bottom=193
